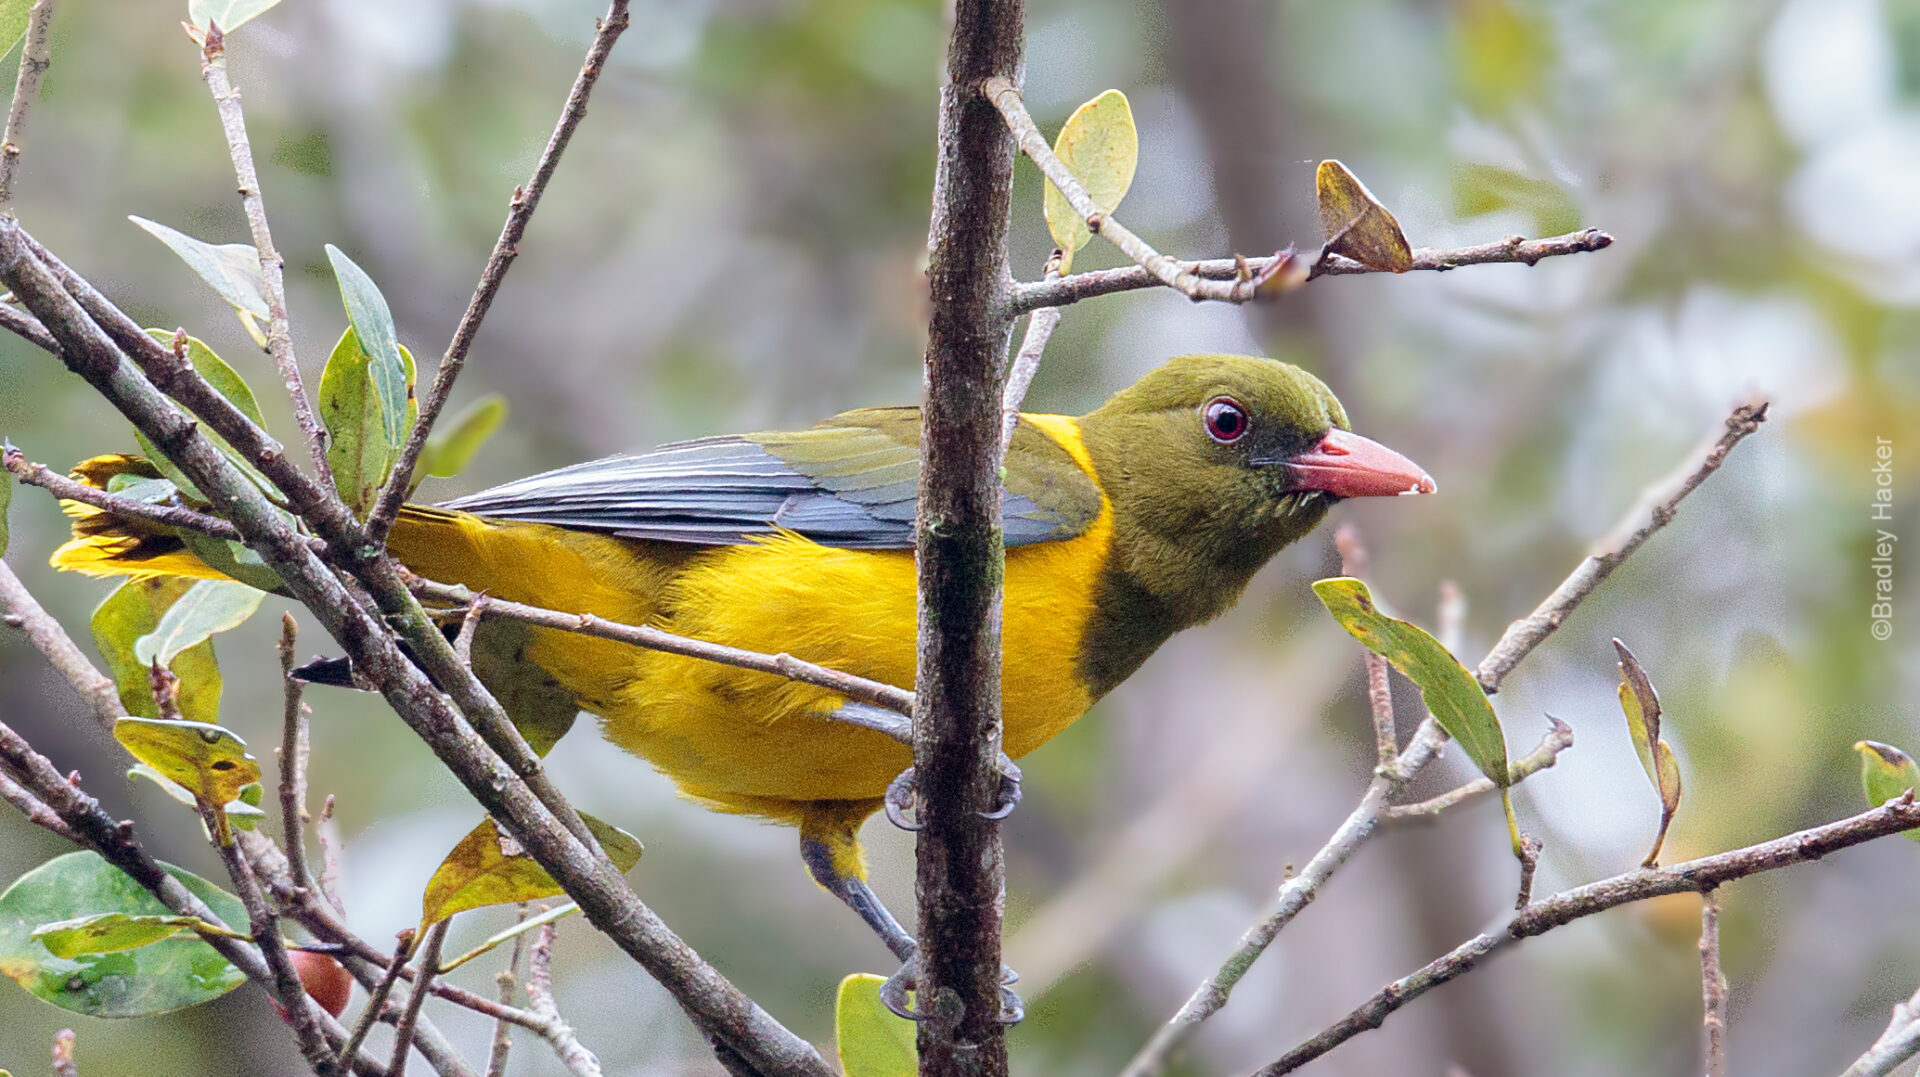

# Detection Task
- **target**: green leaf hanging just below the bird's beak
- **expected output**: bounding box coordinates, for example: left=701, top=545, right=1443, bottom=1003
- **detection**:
left=1313, top=576, right=1513, bottom=789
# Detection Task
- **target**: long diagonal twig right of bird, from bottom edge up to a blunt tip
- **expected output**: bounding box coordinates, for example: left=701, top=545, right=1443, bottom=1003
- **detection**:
left=1123, top=403, right=1766, bottom=1077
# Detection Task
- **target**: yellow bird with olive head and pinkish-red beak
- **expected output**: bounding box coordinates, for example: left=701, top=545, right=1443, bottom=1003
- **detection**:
left=54, top=355, right=1434, bottom=1006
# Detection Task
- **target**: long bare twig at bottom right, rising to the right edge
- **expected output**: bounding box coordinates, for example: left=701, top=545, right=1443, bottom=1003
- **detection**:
left=1258, top=793, right=1920, bottom=1077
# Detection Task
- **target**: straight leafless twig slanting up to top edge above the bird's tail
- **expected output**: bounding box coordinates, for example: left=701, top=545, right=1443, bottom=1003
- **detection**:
left=367, top=0, right=632, bottom=541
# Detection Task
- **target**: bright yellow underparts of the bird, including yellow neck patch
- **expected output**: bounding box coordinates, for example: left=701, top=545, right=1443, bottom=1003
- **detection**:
left=394, top=417, right=1114, bottom=820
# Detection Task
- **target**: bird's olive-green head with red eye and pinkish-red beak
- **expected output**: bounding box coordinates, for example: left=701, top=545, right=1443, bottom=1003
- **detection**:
left=1081, top=355, right=1434, bottom=620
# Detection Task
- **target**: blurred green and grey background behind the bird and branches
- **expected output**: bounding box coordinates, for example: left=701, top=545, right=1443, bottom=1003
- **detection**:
left=0, top=0, right=1920, bottom=1077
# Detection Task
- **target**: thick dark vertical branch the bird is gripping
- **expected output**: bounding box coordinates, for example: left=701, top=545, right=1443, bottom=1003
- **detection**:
left=914, top=0, right=1023, bottom=1077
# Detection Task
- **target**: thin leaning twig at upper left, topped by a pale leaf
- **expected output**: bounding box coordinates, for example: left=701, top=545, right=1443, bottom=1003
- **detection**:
left=200, top=25, right=334, bottom=488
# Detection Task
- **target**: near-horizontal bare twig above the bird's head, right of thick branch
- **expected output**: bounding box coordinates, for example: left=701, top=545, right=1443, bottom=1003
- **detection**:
left=1010, top=228, right=1613, bottom=315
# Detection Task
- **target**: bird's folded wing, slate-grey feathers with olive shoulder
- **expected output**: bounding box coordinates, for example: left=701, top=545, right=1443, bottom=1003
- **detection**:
left=433, top=407, right=1100, bottom=549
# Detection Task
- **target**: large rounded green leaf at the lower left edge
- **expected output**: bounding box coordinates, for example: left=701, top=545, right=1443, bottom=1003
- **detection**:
left=0, top=852, right=246, bottom=1017
